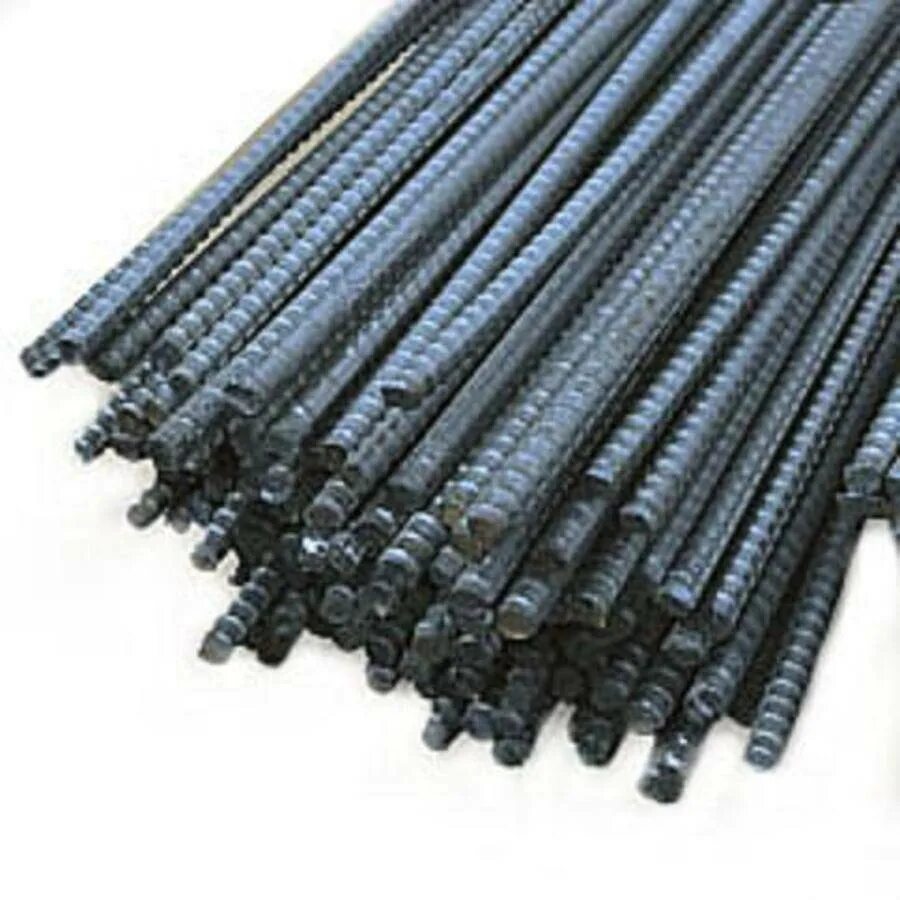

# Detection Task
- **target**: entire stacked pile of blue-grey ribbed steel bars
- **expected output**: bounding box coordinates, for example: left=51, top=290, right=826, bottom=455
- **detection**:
left=23, top=0, right=900, bottom=802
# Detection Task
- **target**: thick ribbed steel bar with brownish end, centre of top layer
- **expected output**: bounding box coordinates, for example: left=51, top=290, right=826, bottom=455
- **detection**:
left=450, top=7, right=883, bottom=568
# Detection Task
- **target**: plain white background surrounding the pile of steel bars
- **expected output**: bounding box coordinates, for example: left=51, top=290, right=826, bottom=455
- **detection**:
left=0, top=0, right=900, bottom=900
